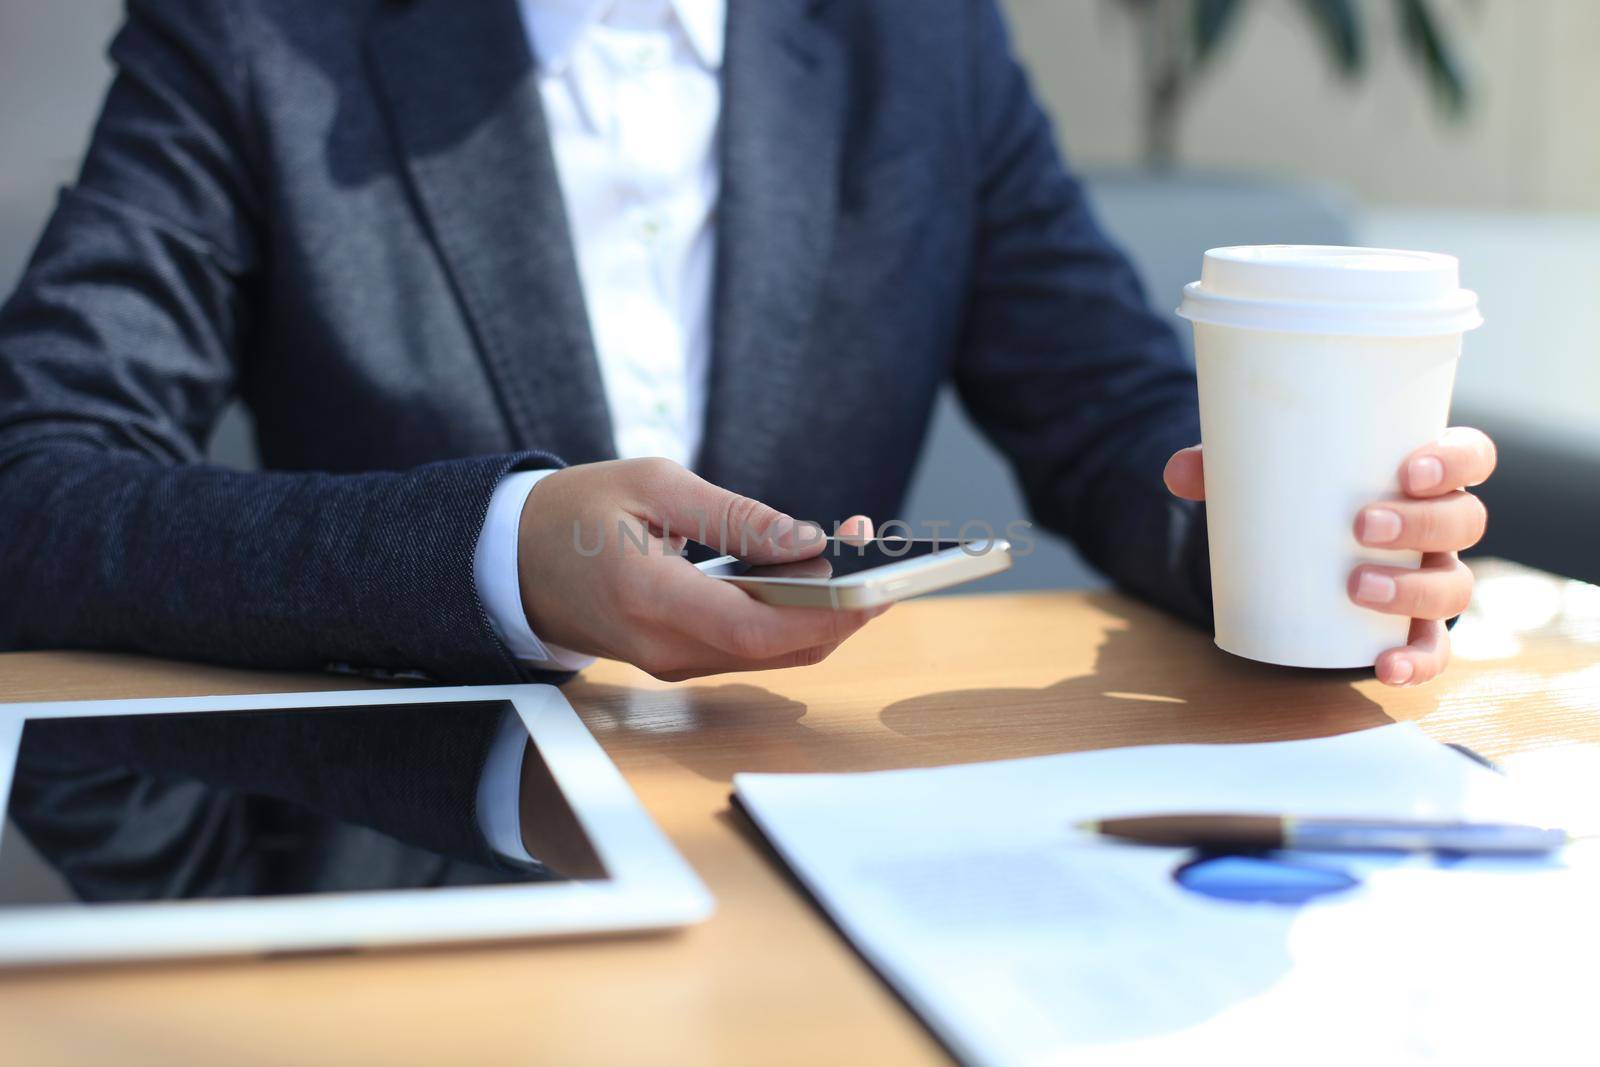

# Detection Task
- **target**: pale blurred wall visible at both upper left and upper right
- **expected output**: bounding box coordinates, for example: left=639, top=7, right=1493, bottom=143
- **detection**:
left=12, top=0, right=1600, bottom=225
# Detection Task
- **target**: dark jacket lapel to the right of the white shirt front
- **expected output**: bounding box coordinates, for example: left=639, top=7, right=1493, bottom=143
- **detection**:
left=699, top=0, right=845, bottom=496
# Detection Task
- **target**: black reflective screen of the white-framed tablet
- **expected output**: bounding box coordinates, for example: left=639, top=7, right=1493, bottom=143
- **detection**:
left=0, top=701, right=605, bottom=907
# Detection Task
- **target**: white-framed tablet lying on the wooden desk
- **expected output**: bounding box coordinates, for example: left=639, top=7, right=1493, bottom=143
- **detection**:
left=0, top=685, right=712, bottom=965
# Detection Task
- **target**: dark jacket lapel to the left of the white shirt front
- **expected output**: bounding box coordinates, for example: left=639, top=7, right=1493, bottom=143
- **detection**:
left=371, top=0, right=614, bottom=462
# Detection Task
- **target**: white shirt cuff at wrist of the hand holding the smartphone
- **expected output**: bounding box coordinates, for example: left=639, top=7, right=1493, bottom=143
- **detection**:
left=472, top=470, right=595, bottom=670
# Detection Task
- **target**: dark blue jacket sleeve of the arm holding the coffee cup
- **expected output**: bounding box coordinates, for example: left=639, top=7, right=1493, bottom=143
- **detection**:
left=955, top=0, right=1211, bottom=622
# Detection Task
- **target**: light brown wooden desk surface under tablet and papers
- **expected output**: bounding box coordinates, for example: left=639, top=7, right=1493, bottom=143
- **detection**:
left=0, top=563, right=1600, bottom=1064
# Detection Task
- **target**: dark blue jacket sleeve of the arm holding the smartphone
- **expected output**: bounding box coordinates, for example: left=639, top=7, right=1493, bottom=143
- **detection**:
left=0, top=0, right=558, bottom=681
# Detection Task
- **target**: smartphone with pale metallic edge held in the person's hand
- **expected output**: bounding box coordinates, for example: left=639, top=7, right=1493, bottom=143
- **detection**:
left=696, top=537, right=1011, bottom=611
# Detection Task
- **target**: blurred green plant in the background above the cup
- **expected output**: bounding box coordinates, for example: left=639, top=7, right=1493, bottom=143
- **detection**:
left=1122, top=0, right=1469, bottom=170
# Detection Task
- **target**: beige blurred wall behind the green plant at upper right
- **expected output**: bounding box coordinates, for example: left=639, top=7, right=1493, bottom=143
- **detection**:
left=1005, top=0, right=1600, bottom=211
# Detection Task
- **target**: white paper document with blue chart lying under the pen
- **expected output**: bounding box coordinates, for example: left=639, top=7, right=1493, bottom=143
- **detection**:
left=734, top=725, right=1600, bottom=1065
